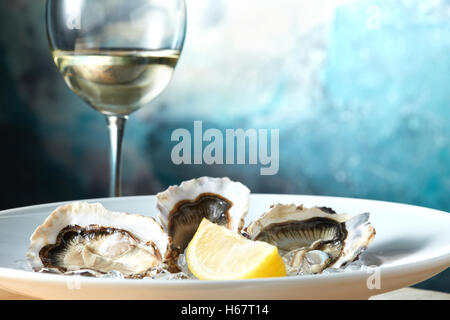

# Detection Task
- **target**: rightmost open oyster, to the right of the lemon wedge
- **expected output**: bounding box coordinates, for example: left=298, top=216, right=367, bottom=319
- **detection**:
left=245, top=204, right=375, bottom=275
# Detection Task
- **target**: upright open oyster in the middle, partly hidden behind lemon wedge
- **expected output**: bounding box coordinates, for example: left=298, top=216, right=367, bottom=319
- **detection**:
left=156, top=177, right=250, bottom=269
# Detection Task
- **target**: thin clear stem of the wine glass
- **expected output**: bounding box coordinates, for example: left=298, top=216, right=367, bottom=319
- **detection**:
left=106, top=116, right=128, bottom=197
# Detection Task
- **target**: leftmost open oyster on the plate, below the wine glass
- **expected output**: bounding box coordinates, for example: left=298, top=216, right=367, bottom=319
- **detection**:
left=27, top=202, right=168, bottom=278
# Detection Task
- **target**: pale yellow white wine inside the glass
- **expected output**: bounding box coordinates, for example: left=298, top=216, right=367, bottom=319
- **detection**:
left=53, top=49, right=180, bottom=115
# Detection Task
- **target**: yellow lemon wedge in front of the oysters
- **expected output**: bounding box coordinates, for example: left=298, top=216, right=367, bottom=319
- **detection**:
left=186, top=219, right=286, bottom=280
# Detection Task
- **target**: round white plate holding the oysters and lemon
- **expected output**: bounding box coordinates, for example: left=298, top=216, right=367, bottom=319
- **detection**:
left=0, top=194, right=450, bottom=299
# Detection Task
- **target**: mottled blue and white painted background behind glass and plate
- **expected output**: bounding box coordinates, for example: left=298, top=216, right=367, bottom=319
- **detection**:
left=0, top=0, right=450, bottom=292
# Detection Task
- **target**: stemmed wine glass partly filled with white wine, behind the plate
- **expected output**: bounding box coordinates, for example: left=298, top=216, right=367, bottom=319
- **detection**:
left=46, top=0, right=186, bottom=197
